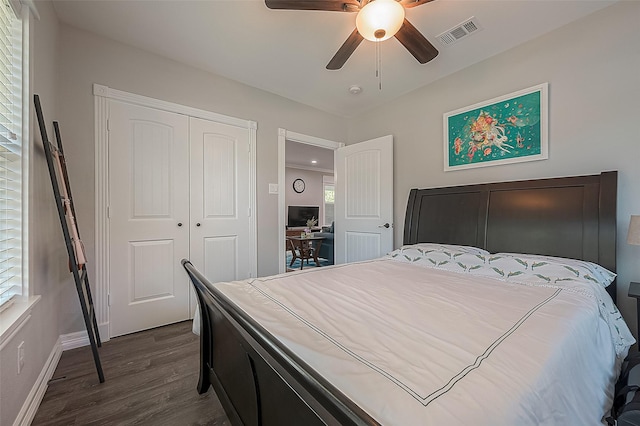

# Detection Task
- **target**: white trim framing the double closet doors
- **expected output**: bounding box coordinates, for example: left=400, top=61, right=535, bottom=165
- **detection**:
left=93, top=84, right=258, bottom=341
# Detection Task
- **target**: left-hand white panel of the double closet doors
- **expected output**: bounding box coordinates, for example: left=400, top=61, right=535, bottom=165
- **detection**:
left=109, top=101, right=189, bottom=337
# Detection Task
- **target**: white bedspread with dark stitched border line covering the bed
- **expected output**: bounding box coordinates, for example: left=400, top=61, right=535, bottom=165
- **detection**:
left=215, top=259, right=632, bottom=426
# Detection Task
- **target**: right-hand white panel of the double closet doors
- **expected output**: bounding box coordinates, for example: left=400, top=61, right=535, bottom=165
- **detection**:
left=190, top=118, right=253, bottom=282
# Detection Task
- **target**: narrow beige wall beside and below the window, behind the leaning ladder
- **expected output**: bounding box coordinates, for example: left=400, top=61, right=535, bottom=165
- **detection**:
left=0, top=3, right=66, bottom=425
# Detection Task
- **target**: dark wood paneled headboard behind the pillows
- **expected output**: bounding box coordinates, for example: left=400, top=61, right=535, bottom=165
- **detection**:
left=404, top=171, right=618, bottom=302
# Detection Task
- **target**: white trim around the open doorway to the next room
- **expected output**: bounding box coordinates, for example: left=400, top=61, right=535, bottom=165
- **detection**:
left=278, top=128, right=345, bottom=274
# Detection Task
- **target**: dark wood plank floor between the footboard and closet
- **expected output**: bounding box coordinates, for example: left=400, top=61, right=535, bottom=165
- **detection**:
left=32, top=321, right=230, bottom=425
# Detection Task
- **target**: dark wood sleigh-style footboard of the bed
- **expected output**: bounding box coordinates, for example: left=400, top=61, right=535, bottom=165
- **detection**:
left=182, top=259, right=378, bottom=426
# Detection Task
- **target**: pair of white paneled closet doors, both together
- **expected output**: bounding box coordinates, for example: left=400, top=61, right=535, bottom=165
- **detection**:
left=109, top=101, right=251, bottom=337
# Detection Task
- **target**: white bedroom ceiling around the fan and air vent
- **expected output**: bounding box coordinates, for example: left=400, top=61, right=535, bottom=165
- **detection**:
left=53, top=0, right=616, bottom=116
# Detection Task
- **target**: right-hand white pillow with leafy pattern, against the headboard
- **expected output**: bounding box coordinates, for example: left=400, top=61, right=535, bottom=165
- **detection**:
left=492, top=253, right=616, bottom=287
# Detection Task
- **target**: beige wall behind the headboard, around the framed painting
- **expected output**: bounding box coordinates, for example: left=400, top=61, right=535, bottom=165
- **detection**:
left=348, top=1, right=640, bottom=329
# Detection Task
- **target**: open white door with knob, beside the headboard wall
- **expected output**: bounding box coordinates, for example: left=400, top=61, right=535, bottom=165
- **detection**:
left=334, top=135, right=393, bottom=263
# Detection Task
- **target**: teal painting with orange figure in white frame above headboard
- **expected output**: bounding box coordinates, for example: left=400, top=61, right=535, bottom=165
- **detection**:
left=444, top=83, right=548, bottom=171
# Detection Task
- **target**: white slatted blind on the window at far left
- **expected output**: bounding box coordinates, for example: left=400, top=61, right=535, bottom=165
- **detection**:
left=0, top=0, right=22, bottom=310
